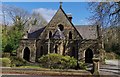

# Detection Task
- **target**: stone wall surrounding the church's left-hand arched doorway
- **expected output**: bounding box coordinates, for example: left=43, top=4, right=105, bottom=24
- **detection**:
left=17, top=39, right=36, bottom=62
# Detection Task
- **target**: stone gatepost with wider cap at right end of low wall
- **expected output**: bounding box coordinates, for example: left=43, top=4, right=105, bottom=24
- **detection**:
left=92, top=58, right=100, bottom=75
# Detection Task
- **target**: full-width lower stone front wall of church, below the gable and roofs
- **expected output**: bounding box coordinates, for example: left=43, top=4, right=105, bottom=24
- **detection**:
left=17, top=39, right=100, bottom=62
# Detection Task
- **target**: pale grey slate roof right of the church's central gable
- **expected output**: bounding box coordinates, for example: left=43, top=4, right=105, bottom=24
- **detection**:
left=75, top=25, right=98, bottom=39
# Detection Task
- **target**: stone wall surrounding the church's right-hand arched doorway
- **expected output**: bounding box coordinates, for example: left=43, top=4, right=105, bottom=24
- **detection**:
left=78, top=40, right=99, bottom=61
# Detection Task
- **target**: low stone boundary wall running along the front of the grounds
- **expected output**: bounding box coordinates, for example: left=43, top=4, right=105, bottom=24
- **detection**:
left=2, top=68, right=92, bottom=77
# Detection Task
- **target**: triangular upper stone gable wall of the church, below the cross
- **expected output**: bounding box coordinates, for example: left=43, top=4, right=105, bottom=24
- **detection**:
left=39, top=9, right=82, bottom=39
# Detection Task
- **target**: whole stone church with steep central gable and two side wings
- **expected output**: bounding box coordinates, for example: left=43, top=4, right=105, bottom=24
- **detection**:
left=17, top=5, right=101, bottom=63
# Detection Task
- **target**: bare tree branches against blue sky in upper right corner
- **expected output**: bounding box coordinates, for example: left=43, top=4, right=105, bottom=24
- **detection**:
left=89, top=2, right=120, bottom=27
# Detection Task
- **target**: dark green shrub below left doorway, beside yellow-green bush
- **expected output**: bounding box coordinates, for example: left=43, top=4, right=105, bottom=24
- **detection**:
left=11, top=56, right=27, bottom=67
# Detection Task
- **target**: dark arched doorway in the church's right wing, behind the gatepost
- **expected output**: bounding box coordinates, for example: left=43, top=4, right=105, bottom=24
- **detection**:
left=85, top=48, right=93, bottom=63
